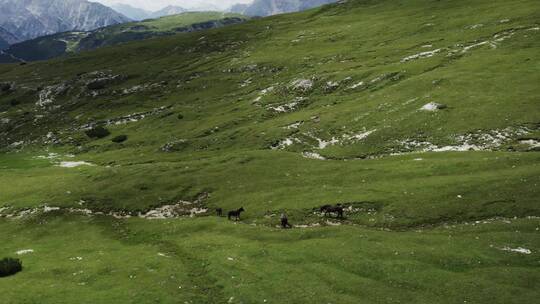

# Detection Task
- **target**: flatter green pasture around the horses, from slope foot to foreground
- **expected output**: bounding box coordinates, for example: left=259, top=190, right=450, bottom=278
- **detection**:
left=0, top=151, right=540, bottom=304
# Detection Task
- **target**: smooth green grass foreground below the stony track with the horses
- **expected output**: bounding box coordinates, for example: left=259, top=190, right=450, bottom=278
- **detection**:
left=0, top=214, right=540, bottom=304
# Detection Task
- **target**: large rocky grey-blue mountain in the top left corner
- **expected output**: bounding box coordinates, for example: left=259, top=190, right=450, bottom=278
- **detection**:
left=0, top=0, right=129, bottom=47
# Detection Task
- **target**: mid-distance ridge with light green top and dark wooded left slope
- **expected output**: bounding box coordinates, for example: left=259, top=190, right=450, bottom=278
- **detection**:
left=0, top=12, right=247, bottom=61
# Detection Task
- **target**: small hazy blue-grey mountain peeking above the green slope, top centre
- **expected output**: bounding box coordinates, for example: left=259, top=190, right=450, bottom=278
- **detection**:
left=230, top=0, right=338, bottom=17
